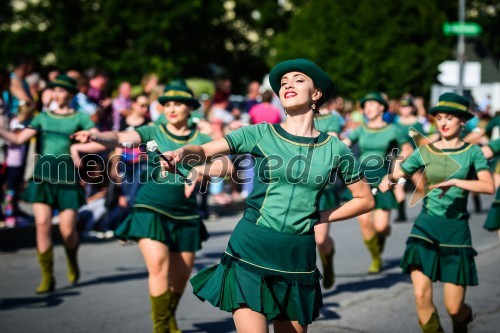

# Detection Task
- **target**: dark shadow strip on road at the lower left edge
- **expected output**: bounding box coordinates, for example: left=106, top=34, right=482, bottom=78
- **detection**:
left=0, top=291, right=80, bottom=311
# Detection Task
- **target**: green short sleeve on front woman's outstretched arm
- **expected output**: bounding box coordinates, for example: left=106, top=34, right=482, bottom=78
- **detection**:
left=224, top=123, right=270, bottom=154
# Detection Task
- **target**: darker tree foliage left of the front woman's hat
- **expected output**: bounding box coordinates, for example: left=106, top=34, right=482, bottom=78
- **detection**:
left=0, top=0, right=290, bottom=92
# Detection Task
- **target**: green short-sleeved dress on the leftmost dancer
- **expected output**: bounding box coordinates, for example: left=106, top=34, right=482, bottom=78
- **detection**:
left=23, top=111, right=95, bottom=210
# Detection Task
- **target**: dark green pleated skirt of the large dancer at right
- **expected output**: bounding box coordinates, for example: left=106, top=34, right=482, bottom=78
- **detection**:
left=400, top=213, right=478, bottom=286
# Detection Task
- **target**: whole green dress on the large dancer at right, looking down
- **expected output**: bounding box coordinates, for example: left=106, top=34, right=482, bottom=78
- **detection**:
left=400, top=143, right=488, bottom=286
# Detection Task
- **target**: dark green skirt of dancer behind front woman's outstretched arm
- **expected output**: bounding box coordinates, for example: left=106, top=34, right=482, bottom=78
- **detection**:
left=115, top=206, right=208, bottom=252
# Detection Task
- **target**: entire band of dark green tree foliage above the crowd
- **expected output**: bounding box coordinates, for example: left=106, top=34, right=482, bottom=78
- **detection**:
left=0, top=0, right=500, bottom=98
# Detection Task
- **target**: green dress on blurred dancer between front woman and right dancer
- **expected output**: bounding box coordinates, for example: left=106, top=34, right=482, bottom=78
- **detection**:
left=349, top=124, right=409, bottom=210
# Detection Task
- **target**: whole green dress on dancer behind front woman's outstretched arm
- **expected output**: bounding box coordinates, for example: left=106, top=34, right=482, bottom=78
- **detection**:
left=115, top=125, right=211, bottom=252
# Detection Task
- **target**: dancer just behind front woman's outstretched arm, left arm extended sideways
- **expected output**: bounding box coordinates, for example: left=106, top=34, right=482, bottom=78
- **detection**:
left=75, top=80, right=231, bottom=333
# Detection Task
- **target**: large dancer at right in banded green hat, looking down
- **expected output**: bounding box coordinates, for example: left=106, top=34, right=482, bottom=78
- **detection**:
left=379, top=93, right=494, bottom=333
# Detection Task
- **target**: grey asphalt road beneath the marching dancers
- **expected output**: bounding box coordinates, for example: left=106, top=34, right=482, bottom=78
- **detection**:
left=0, top=196, right=500, bottom=333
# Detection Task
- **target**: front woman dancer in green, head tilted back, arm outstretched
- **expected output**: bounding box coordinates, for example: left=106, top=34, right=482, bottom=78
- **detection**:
left=158, top=59, right=373, bottom=333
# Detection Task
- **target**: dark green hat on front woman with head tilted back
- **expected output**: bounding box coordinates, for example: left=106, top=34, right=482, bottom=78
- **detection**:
left=269, top=58, right=333, bottom=107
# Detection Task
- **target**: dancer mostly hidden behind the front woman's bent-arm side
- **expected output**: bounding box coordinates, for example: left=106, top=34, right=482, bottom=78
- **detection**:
left=314, top=110, right=341, bottom=289
